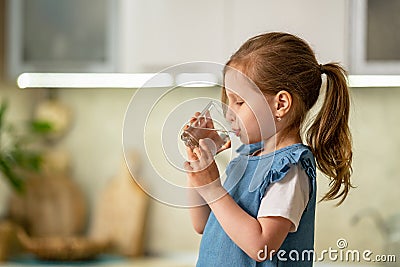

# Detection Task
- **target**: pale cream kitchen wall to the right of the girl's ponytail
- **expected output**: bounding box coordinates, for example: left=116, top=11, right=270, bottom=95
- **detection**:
left=316, top=88, right=400, bottom=253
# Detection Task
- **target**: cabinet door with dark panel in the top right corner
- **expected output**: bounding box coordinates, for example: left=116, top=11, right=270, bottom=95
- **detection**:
left=349, top=0, right=400, bottom=74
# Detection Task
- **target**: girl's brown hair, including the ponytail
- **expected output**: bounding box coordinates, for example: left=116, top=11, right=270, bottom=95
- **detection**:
left=222, top=32, right=353, bottom=205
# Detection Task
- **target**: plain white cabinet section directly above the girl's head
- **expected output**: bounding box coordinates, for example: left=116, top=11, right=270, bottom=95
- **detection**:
left=226, top=0, right=348, bottom=63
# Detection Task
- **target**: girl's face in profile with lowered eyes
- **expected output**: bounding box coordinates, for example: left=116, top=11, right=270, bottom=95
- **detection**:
left=225, top=69, right=275, bottom=144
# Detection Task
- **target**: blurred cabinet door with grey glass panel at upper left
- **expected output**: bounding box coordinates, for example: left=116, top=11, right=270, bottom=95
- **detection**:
left=7, top=0, right=116, bottom=78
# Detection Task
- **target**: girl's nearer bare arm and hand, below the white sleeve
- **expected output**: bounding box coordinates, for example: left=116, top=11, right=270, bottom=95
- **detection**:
left=185, top=140, right=292, bottom=261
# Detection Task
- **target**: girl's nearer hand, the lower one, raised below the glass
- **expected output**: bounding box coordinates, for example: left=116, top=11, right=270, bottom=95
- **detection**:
left=184, top=139, right=226, bottom=202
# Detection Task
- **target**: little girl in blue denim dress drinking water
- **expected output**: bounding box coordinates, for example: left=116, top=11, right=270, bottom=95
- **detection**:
left=185, top=32, right=352, bottom=267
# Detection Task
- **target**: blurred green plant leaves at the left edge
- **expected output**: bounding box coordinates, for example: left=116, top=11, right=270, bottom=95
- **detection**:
left=0, top=100, right=52, bottom=193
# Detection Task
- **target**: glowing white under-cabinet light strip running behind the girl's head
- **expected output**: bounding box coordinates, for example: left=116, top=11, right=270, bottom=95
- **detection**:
left=17, top=73, right=400, bottom=88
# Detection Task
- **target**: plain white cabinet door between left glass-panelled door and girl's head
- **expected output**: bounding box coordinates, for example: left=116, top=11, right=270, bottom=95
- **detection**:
left=119, top=0, right=228, bottom=72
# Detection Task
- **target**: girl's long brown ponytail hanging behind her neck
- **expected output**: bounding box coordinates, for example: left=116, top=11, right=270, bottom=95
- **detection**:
left=306, top=63, right=353, bottom=205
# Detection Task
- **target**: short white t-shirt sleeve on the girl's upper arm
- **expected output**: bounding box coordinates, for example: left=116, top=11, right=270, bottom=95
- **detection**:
left=257, top=165, right=310, bottom=232
